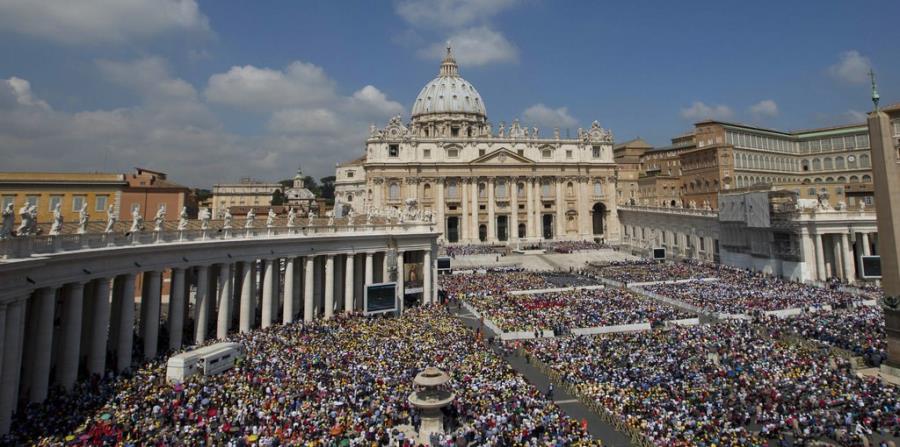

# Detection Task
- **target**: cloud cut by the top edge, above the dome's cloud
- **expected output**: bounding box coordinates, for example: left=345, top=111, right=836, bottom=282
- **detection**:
left=395, top=0, right=517, bottom=28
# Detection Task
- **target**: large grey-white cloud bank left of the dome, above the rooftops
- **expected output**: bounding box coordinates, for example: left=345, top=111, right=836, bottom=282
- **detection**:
left=0, top=57, right=403, bottom=187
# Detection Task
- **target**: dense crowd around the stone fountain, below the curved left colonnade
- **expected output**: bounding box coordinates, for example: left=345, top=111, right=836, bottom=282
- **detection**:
left=10, top=306, right=596, bottom=447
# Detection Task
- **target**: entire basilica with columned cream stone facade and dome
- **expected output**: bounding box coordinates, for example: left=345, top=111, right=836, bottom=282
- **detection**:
left=335, top=48, right=619, bottom=244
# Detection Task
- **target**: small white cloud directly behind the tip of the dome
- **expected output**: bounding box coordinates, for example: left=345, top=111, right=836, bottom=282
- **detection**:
left=419, top=26, right=519, bottom=66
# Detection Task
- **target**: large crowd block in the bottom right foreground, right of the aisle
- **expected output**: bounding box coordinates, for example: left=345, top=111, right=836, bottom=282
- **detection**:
left=524, top=321, right=900, bottom=447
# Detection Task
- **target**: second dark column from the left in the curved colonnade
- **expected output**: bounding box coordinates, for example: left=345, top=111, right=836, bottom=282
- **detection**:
left=28, top=287, right=56, bottom=403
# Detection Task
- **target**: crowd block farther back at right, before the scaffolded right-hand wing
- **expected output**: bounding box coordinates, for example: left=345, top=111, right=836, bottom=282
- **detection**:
left=642, top=268, right=854, bottom=315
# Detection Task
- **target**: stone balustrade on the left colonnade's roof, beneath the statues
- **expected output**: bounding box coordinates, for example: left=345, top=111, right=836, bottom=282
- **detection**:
left=0, top=219, right=434, bottom=261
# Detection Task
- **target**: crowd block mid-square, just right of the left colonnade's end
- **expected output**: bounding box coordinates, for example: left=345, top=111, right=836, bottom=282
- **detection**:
left=466, top=288, right=693, bottom=334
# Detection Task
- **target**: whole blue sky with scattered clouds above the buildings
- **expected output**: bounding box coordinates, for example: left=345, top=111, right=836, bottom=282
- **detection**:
left=0, top=0, right=900, bottom=187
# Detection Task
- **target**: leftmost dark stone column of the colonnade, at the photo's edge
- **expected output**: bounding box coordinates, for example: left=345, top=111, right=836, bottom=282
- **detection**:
left=0, top=297, right=25, bottom=433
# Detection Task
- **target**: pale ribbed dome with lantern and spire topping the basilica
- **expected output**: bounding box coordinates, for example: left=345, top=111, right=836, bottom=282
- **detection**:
left=411, top=46, right=487, bottom=118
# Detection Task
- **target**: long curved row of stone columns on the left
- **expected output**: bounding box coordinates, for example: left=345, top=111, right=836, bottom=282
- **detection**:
left=0, top=243, right=437, bottom=433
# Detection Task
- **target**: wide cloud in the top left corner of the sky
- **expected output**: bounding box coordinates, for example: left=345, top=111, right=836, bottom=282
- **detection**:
left=0, top=0, right=210, bottom=45
